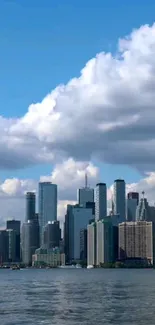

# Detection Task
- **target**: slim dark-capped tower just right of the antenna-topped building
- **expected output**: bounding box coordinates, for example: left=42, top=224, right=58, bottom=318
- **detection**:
left=95, top=183, right=107, bottom=221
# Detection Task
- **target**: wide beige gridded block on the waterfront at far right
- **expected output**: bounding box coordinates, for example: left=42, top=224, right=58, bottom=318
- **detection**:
left=119, top=221, right=155, bottom=264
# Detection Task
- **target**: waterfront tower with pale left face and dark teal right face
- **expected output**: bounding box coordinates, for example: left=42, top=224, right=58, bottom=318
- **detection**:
left=96, top=218, right=114, bottom=266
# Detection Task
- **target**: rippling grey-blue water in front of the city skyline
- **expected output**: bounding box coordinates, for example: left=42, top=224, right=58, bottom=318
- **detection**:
left=0, top=269, right=155, bottom=325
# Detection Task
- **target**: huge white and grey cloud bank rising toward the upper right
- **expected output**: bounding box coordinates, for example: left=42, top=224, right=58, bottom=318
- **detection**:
left=0, top=24, right=155, bottom=171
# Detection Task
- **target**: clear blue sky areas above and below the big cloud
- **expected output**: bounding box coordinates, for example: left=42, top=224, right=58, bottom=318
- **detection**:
left=0, top=0, right=155, bottom=184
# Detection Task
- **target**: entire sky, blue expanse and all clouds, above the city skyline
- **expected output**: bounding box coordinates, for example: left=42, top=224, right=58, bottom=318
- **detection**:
left=0, top=0, right=155, bottom=225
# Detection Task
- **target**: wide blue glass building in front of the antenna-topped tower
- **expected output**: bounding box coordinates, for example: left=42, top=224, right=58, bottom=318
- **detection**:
left=65, top=205, right=93, bottom=262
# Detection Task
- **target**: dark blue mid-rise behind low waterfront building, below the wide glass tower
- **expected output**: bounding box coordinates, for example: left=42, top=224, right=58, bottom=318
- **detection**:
left=44, top=221, right=61, bottom=249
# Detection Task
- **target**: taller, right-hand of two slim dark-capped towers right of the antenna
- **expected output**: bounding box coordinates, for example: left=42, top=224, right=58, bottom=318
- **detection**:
left=113, top=179, right=126, bottom=220
